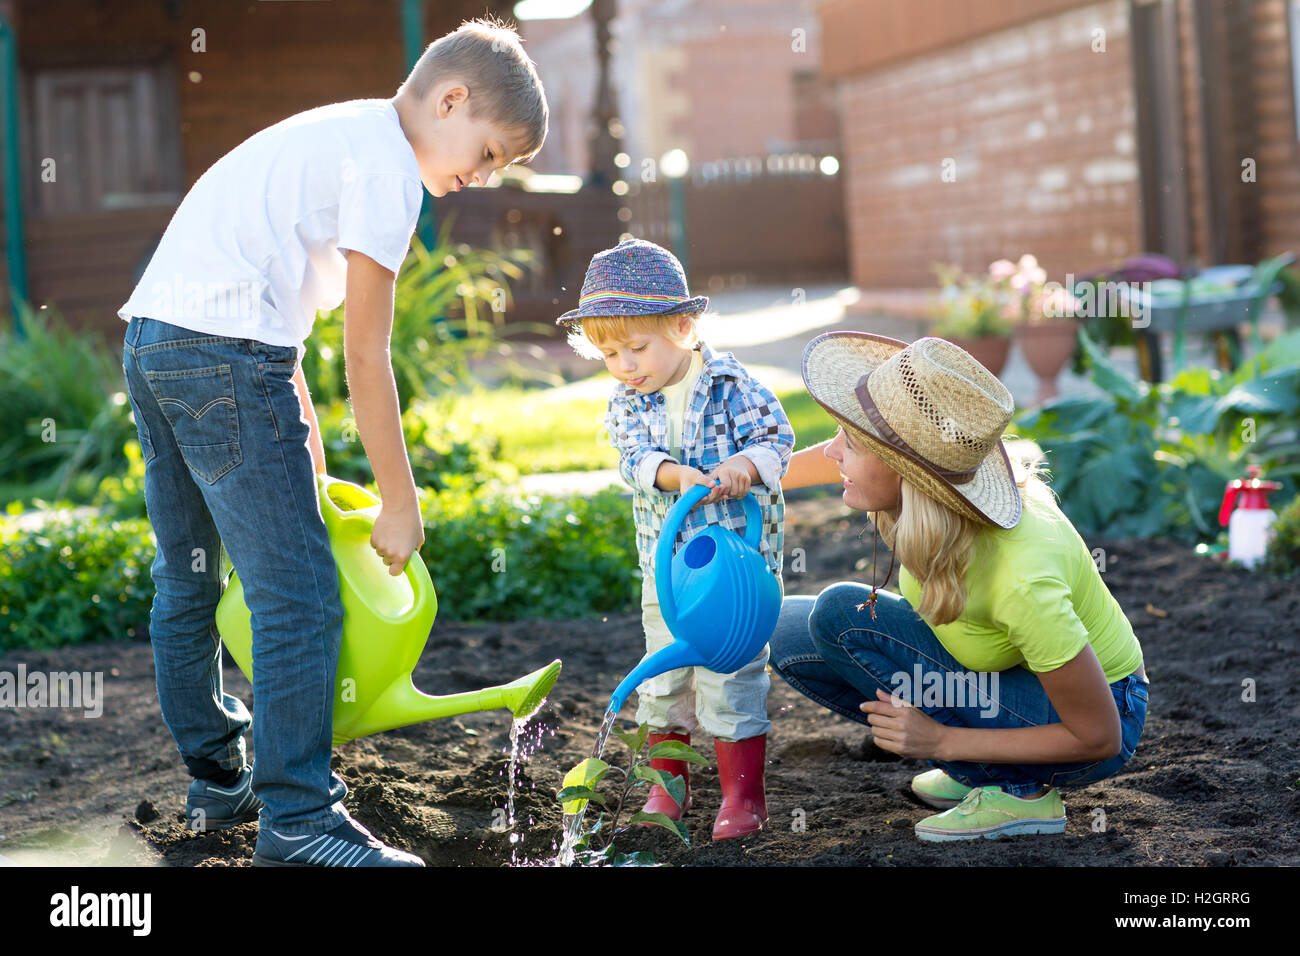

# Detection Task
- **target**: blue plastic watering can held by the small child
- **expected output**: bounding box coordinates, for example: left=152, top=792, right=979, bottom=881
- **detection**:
left=610, top=485, right=781, bottom=713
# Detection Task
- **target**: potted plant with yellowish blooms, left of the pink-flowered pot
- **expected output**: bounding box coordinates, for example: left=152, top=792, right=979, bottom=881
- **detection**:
left=930, top=265, right=1014, bottom=375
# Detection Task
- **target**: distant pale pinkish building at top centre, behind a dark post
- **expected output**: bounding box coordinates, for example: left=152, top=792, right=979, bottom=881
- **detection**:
left=521, top=0, right=839, bottom=173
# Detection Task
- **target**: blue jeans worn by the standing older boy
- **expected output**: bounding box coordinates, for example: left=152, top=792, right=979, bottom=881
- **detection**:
left=122, top=317, right=347, bottom=834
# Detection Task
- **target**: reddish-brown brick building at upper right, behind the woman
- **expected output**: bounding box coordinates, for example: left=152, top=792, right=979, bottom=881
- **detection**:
left=818, top=0, right=1300, bottom=295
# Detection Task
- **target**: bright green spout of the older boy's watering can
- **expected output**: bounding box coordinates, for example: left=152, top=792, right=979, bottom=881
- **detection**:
left=334, top=661, right=560, bottom=745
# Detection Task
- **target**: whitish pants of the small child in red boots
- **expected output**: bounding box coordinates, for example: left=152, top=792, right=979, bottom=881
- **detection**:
left=637, top=576, right=772, bottom=741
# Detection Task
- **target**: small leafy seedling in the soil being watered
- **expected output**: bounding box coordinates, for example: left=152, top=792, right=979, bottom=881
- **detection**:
left=555, top=723, right=709, bottom=866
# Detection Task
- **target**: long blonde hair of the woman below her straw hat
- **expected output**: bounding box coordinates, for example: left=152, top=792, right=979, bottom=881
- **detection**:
left=854, top=436, right=1054, bottom=627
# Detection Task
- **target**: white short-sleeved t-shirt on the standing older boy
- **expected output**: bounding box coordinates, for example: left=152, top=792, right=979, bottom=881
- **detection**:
left=118, top=99, right=424, bottom=359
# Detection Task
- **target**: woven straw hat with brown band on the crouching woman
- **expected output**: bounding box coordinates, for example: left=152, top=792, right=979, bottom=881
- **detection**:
left=803, top=332, right=1021, bottom=528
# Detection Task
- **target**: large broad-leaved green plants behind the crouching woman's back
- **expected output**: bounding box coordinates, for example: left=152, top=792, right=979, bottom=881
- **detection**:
left=1015, top=332, right=1300, bottom=541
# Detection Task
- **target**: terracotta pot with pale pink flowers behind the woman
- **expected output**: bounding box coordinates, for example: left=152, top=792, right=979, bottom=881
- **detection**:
left=988, top=255, right=1079, bottom=405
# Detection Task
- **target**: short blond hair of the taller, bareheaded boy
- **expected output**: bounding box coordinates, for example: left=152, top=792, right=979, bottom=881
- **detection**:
left=398, top=17, right=550, bottom=163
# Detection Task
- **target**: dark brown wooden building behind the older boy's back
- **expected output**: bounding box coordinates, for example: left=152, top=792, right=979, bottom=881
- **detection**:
left=0, top=0, right=618, bottom=334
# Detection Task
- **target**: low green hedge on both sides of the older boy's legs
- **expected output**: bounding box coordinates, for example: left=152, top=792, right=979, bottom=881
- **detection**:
left=0, top=477, right=640, bottom=652
